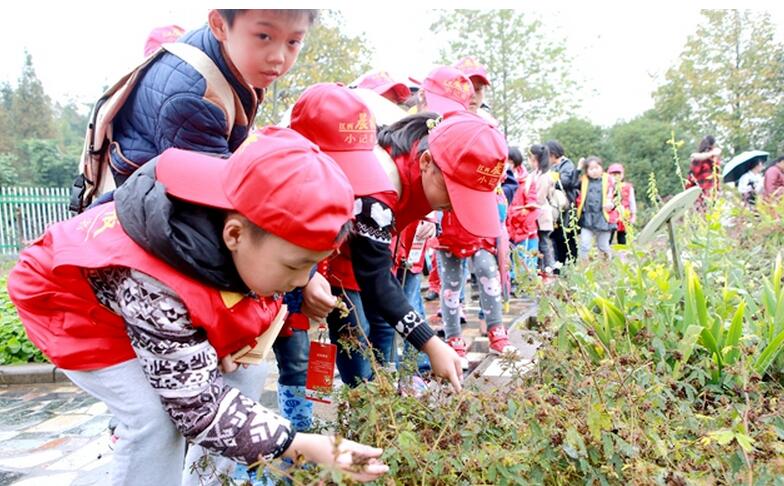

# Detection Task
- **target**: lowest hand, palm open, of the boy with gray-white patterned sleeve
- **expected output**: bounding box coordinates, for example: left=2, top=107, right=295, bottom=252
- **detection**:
left=283, top=433, right=389, bottom=483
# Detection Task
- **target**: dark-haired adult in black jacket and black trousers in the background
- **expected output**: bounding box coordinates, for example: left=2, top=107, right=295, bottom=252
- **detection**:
left=546, top=140, right=580, bottom=265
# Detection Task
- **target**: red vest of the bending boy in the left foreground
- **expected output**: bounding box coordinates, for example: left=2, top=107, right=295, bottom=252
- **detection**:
left=8, top=203, right=281, bottom=370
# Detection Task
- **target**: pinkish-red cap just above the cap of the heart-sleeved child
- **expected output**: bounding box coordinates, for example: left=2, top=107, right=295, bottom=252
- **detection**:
left=409, top=66, right=474, bottom=115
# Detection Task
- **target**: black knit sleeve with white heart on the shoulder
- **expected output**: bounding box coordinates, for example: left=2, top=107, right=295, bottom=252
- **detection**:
left=349, top=197, right=435, bottom=350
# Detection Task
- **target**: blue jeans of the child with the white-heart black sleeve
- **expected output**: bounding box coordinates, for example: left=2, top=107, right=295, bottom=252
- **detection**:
left=327, top=287, right=372, bottom=386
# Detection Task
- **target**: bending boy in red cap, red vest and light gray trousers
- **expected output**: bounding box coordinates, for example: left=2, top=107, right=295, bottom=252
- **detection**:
left=8, top=128, right=387, bottom=485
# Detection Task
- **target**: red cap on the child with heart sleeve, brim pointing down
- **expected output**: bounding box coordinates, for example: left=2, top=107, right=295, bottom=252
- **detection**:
left=428, top=111, right=509, bottom=238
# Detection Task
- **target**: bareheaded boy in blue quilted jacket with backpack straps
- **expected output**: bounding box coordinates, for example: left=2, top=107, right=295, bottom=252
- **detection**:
left=88, top=9, right=334, bottom=456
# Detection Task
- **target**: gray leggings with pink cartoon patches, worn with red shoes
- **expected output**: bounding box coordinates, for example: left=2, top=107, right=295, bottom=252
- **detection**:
left=438, top=250, right=503, bottom=339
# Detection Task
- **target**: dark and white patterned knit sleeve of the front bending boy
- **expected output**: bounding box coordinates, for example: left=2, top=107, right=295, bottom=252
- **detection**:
left=89, top=267, right=294, bottom=464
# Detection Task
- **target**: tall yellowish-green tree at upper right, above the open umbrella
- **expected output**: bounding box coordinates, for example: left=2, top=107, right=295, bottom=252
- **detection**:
left=654, top=10, right=784, bottom=153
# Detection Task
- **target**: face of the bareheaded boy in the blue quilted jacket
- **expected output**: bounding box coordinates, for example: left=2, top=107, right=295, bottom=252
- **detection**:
left=209, top=10, right=310, bottom=89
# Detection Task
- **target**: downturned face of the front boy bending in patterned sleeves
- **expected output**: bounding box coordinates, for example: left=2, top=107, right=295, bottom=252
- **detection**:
left=223, top=215, right=331, bottom=297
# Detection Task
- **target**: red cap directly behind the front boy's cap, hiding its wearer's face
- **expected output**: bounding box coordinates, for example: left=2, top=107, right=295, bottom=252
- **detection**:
left=291, top=83, right=395, bottom=196
